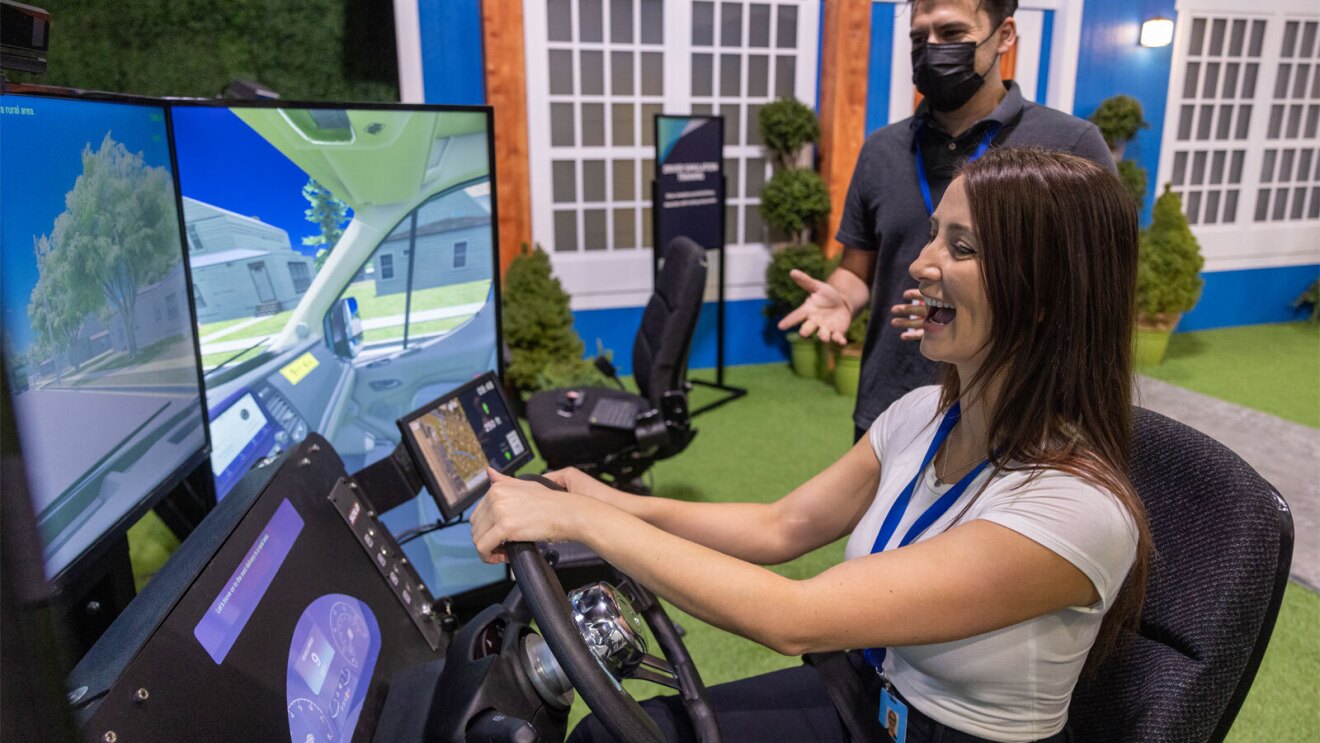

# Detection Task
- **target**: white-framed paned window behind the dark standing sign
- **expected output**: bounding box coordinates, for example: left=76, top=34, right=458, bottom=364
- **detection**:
left=523, top=0, right=820, bottom=307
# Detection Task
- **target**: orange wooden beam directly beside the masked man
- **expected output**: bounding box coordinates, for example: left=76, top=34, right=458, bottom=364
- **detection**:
left=820, top=0, right=871, bottom=256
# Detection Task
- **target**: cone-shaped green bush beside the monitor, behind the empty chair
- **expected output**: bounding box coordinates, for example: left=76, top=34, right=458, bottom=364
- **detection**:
left=502, top=244, right=601, bottom=393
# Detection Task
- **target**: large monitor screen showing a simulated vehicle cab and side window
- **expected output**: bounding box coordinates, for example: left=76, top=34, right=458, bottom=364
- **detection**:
left=172, top=102, right=504, bottom=593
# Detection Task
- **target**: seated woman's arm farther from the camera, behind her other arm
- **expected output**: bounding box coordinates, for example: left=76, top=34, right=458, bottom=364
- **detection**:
left=548, top=437, right=880, bottom=565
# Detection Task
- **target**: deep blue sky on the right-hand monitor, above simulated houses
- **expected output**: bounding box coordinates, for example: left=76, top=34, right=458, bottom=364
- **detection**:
left=173, top=106, right=352, bottom=256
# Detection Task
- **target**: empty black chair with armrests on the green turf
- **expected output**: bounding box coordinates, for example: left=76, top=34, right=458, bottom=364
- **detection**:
left=527, top=238, right=706, bottom=491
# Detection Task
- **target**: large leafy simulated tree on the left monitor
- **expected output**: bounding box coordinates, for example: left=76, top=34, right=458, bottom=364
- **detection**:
left=28, top=132, right=182, bottom=356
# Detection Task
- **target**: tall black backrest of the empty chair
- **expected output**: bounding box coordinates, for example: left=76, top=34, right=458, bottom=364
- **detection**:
left=632, top=238, right=706, bottom=408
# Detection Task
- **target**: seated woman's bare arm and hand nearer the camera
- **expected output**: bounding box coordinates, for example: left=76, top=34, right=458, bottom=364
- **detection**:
left=471, top=475, right=1098, bottom=655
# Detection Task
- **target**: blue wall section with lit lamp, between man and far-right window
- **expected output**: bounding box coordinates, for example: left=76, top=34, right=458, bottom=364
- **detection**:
left=1073, top=0, right=1177, bottom=224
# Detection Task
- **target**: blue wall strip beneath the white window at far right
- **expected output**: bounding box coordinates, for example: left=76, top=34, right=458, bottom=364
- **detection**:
left=1177, top=265, right=1320, bottom=333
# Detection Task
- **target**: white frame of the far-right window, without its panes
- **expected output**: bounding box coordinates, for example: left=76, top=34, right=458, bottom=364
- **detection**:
left=1152, top=0, right=1320, bottom=272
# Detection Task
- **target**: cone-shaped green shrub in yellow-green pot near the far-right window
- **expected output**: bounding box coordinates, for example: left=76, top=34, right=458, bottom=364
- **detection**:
left=1137, top=183, right=1205, bottom=364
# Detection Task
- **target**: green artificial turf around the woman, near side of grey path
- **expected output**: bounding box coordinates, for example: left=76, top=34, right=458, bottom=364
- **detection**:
left=557, top=361, right=1320, bottom=743
